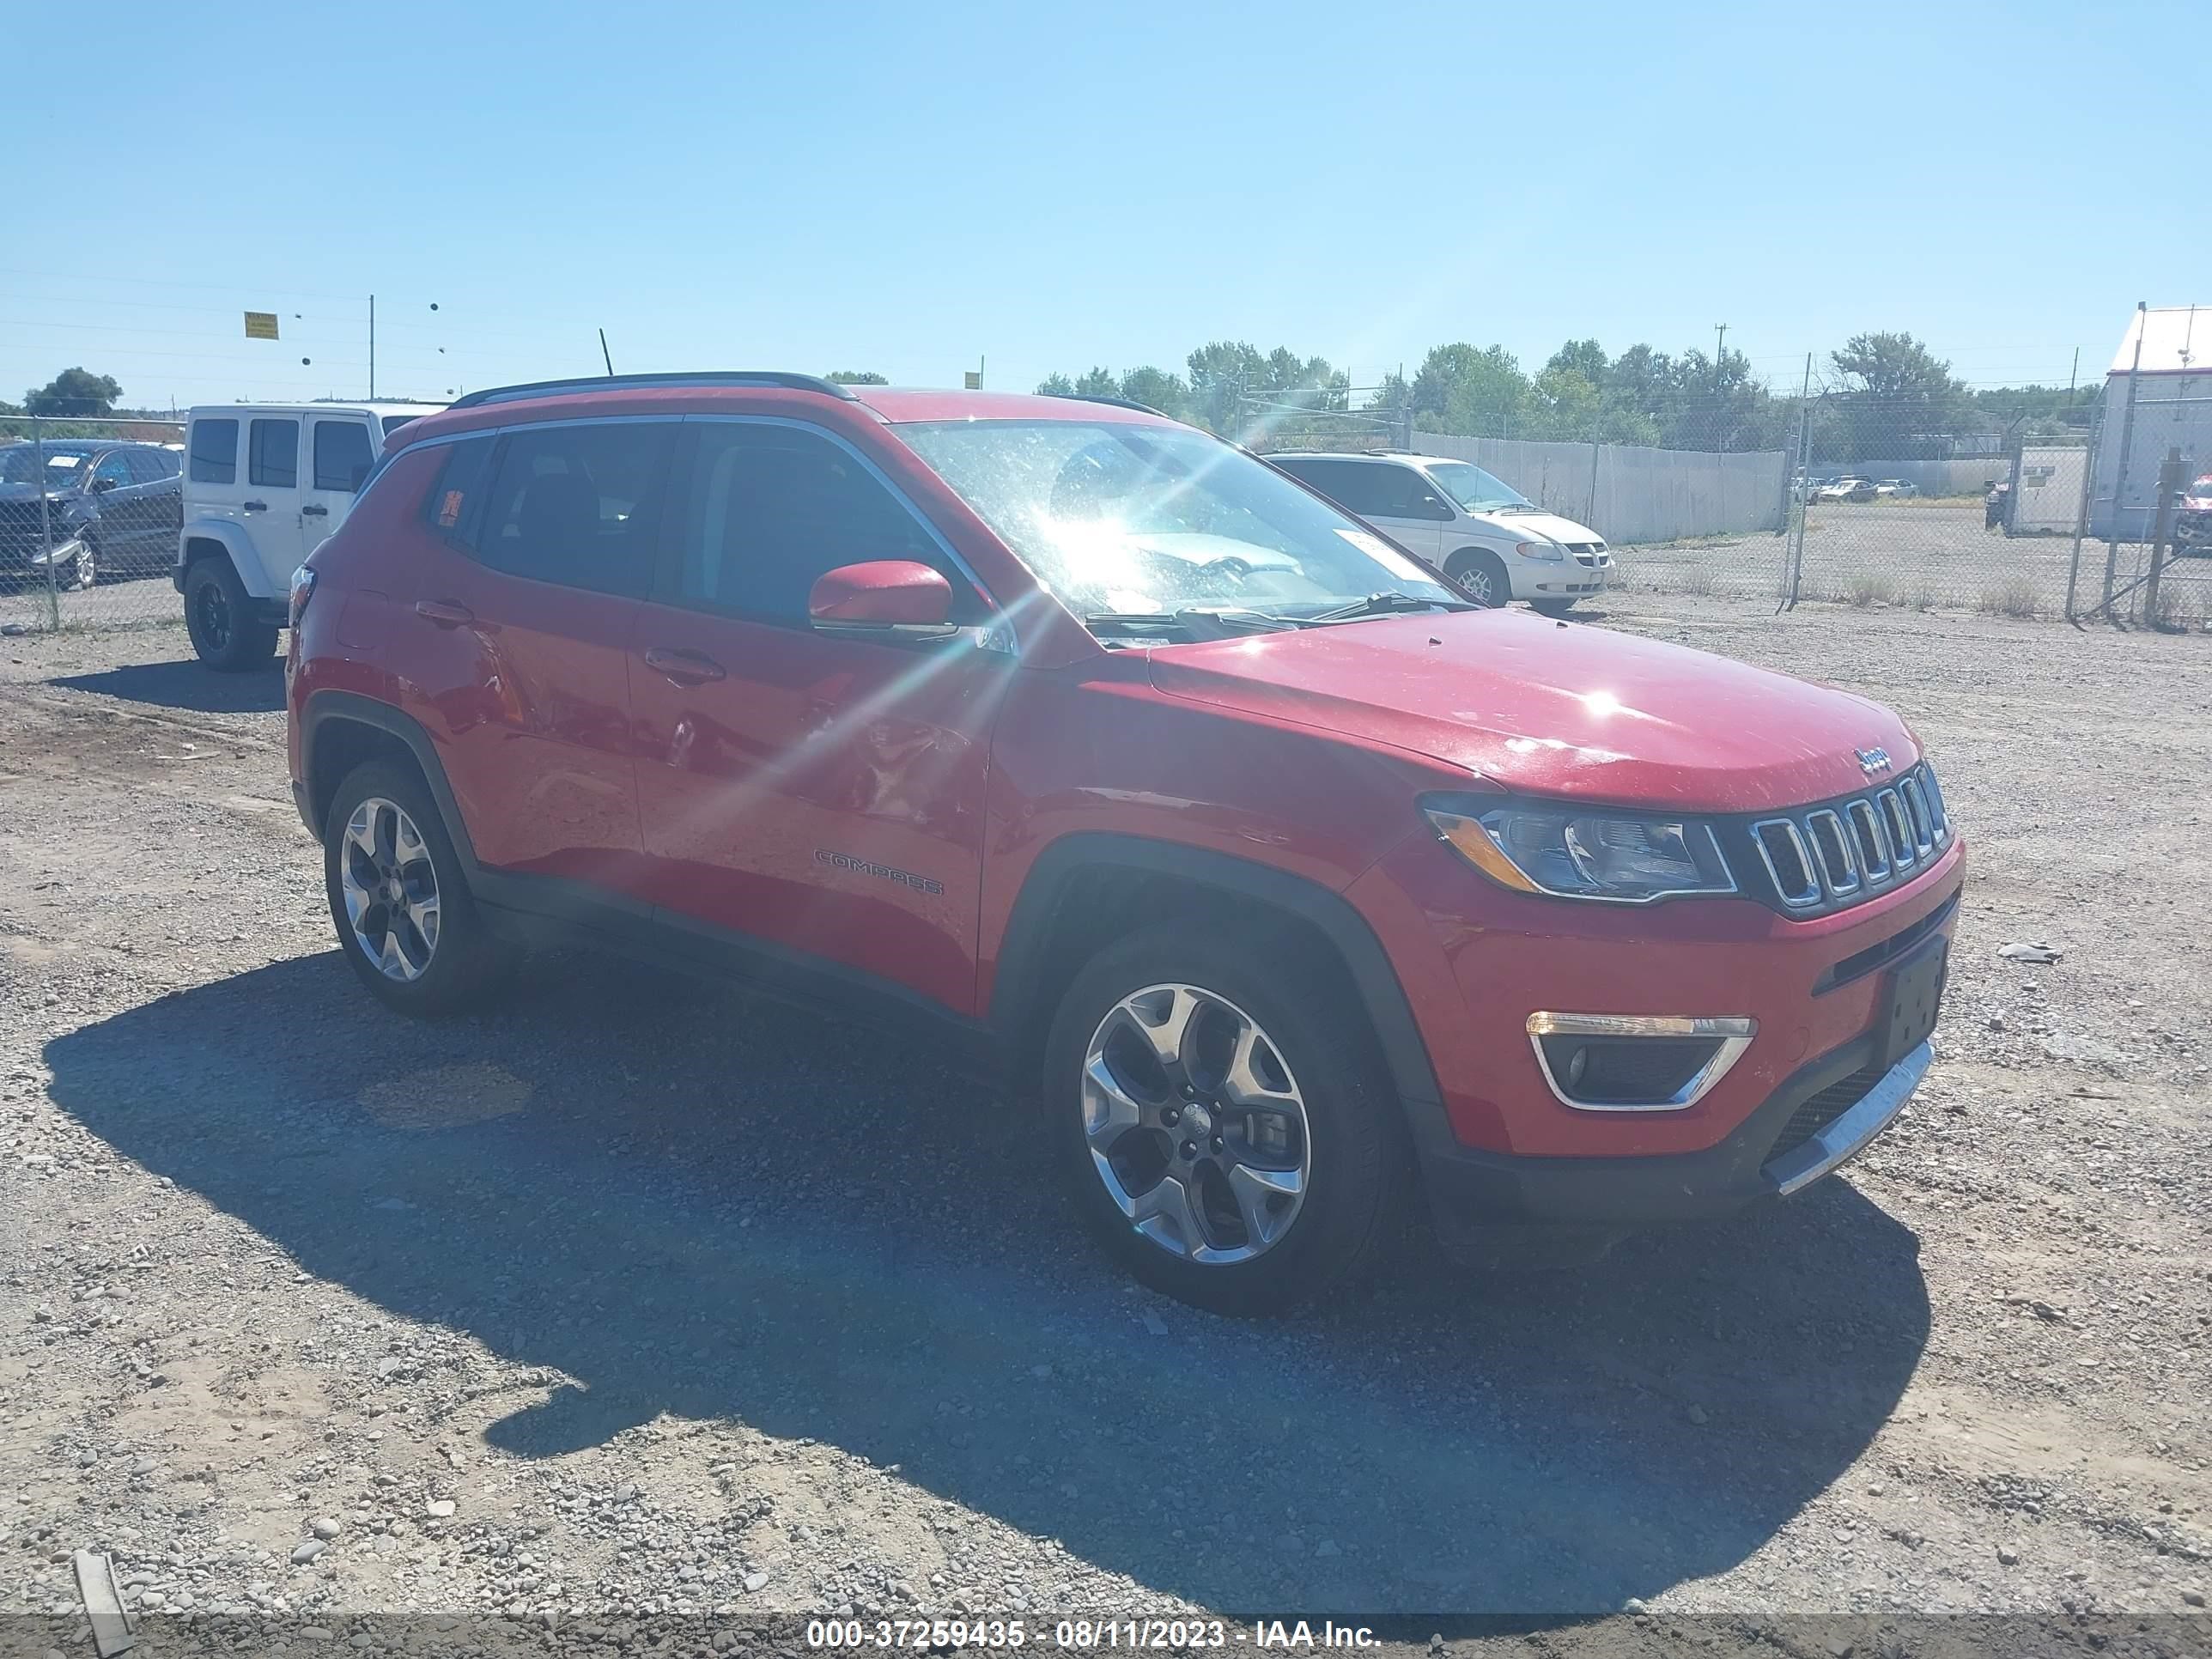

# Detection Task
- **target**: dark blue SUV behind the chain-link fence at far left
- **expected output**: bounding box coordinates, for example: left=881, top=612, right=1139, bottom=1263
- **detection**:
left=0, top=438, right=181, bottom=588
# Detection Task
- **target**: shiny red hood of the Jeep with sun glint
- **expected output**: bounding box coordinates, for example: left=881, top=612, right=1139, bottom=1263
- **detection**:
left=1151, top=611, right=1920, bottom=811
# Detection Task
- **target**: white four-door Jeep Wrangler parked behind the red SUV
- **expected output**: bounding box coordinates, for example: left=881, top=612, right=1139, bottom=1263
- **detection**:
left=168, top=403, right=445, bottom=671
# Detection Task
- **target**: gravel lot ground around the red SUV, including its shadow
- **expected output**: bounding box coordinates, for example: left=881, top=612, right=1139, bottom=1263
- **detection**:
left=0, top=598, right=2212, bottom=1652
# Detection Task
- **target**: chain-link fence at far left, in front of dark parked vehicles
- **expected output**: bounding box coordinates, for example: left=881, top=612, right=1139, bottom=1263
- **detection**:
left=0, top=416, right=184, bottom=633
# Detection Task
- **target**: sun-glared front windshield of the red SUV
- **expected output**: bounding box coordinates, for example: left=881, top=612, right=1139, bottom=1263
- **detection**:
left=898, top=420, right=1460, bottom=633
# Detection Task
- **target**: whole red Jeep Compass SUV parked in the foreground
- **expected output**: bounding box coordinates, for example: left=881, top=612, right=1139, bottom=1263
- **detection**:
left=288, top=374, right=1960, bottom=1312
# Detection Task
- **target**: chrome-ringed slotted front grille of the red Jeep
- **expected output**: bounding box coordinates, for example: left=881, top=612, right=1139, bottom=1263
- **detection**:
left=1750, top=761, right=1951, bottom=911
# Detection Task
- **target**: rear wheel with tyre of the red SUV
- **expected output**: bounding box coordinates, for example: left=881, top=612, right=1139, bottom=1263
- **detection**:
left=323, top=761, right=511, bottom=1013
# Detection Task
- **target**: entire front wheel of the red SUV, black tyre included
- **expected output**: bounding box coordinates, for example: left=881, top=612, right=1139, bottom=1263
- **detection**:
left=1044, top=922, right=1407, bottom=1314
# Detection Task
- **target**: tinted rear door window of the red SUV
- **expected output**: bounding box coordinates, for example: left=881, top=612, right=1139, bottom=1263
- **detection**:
left=471, top=422, right=675, bottom=598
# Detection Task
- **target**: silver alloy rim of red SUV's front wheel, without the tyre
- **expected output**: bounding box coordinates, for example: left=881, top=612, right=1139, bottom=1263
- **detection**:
left=1082, top=984, right=1312, bottom=1265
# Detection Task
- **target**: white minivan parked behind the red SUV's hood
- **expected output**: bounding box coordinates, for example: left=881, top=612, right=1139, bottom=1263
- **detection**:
left=1267, top=452, right=1613, bottom=617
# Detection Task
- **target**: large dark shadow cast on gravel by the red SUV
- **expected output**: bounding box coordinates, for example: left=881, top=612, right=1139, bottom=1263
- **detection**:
left=46, top=951, right=1929, bottom=1614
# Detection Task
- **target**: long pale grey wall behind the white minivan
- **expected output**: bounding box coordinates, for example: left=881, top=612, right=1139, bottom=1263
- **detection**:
left=1413, top=431, right=1790, bottom=542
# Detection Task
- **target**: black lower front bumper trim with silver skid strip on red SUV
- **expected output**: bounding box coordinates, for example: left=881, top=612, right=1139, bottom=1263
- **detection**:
left=1420, top=1033, right=1931, bottom=1243
